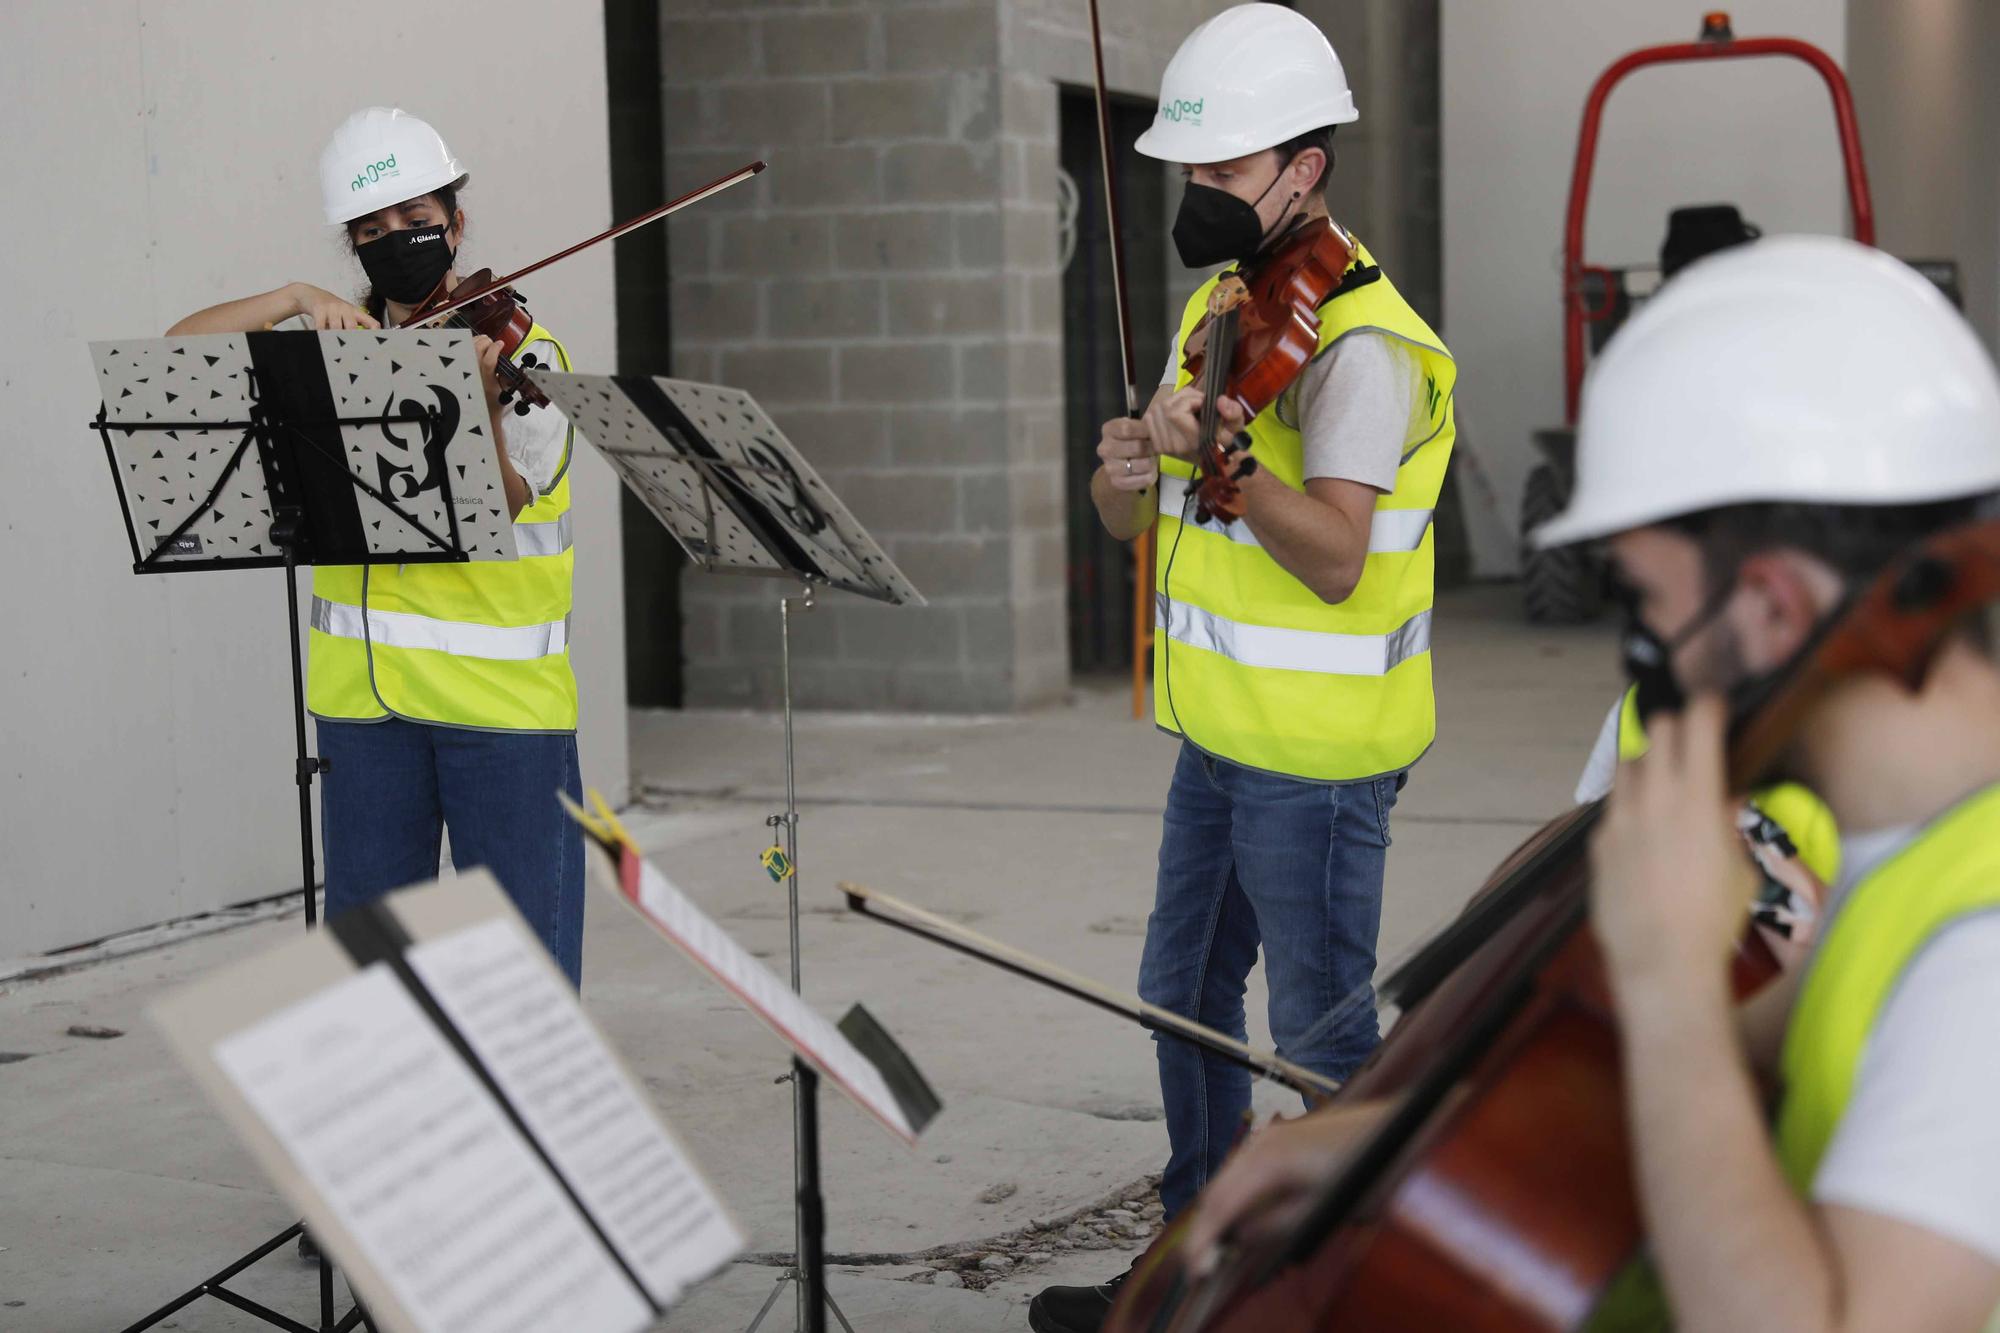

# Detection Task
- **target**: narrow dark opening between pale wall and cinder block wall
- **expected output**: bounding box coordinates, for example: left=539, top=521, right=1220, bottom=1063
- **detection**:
left=604, top=0, right=686, bottom=709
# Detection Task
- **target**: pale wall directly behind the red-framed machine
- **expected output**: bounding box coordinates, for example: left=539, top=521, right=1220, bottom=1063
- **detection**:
left=1442, top=0, right=1848, bottom=572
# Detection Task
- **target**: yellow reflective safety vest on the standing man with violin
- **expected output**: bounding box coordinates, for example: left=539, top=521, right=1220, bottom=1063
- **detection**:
left=1152, top=246, right=1458, bottom=783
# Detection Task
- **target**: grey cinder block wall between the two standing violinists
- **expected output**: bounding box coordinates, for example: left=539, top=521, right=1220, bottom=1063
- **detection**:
left=662, top=0, right=1224, bottom=711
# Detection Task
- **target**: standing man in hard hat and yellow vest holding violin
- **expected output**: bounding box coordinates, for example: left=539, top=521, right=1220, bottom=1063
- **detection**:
left=1030, top=4, right=1456, bottom=1333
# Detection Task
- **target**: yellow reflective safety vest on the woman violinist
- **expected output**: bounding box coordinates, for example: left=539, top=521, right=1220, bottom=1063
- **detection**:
left=306, top=324, right=576, bottom=731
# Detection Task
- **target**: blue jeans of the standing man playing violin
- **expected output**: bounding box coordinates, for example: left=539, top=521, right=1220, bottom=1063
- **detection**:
left=1138, top=743, right=1408, bottom=1217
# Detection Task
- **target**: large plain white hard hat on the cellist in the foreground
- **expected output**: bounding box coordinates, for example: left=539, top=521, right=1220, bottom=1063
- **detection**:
left=1534, top=236, right=2000, bottom=548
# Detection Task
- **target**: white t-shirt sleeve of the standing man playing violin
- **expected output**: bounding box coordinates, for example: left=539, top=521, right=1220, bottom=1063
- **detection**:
left=1160, top=332, right=1420, bottom=492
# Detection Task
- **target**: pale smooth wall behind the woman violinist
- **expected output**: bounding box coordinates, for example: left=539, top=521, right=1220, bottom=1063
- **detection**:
left=0, top=0, right=626, bottom=957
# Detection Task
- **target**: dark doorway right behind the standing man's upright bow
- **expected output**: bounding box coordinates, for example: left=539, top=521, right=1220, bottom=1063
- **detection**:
left=1062, top=88, right=1172, bottom=673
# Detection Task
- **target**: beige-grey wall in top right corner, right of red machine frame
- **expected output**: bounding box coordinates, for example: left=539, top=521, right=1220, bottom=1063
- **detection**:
left=1848, top=0, right=2000, bottom=346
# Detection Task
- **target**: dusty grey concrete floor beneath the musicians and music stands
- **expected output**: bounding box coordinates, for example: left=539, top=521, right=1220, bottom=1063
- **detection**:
left=0, top=588, right=1616, bottom=1333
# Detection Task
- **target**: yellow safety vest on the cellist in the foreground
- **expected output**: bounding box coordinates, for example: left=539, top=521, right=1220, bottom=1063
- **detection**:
left=1778, top=787, right=2000, bottom=1195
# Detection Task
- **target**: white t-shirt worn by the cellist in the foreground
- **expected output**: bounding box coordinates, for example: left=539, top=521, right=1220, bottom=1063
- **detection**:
left=1812, top=829, right=2000, bottom=1263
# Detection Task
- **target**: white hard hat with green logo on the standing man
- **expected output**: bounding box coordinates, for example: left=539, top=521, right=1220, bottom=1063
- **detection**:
left=1136, top=4, right=1360, bottom=164
